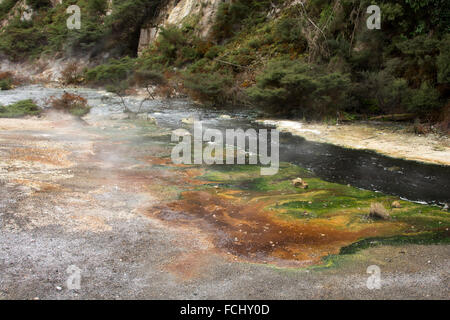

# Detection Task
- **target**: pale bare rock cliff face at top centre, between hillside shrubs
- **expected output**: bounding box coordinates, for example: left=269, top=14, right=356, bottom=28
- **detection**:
left=134, top=0, right=224, bottom=53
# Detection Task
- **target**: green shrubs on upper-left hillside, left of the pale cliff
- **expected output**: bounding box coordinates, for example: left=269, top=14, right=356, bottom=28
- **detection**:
left=0, top=0, right=162, bottom=61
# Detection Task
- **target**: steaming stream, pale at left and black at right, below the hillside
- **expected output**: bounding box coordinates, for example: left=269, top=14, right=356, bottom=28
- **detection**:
left=0, top=86, right=450, bottom=204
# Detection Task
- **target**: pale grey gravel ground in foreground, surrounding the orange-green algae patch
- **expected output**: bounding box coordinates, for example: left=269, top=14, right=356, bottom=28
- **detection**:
left=0, top=118, right=450, bottom=299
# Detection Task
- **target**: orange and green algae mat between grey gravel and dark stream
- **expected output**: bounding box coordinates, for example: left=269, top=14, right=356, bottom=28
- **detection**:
left=89, top=121, right=450, bottom=267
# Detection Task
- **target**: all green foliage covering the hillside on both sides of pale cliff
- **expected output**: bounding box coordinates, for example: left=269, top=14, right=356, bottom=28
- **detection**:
left=0, top=0, right=450, bottom=123
